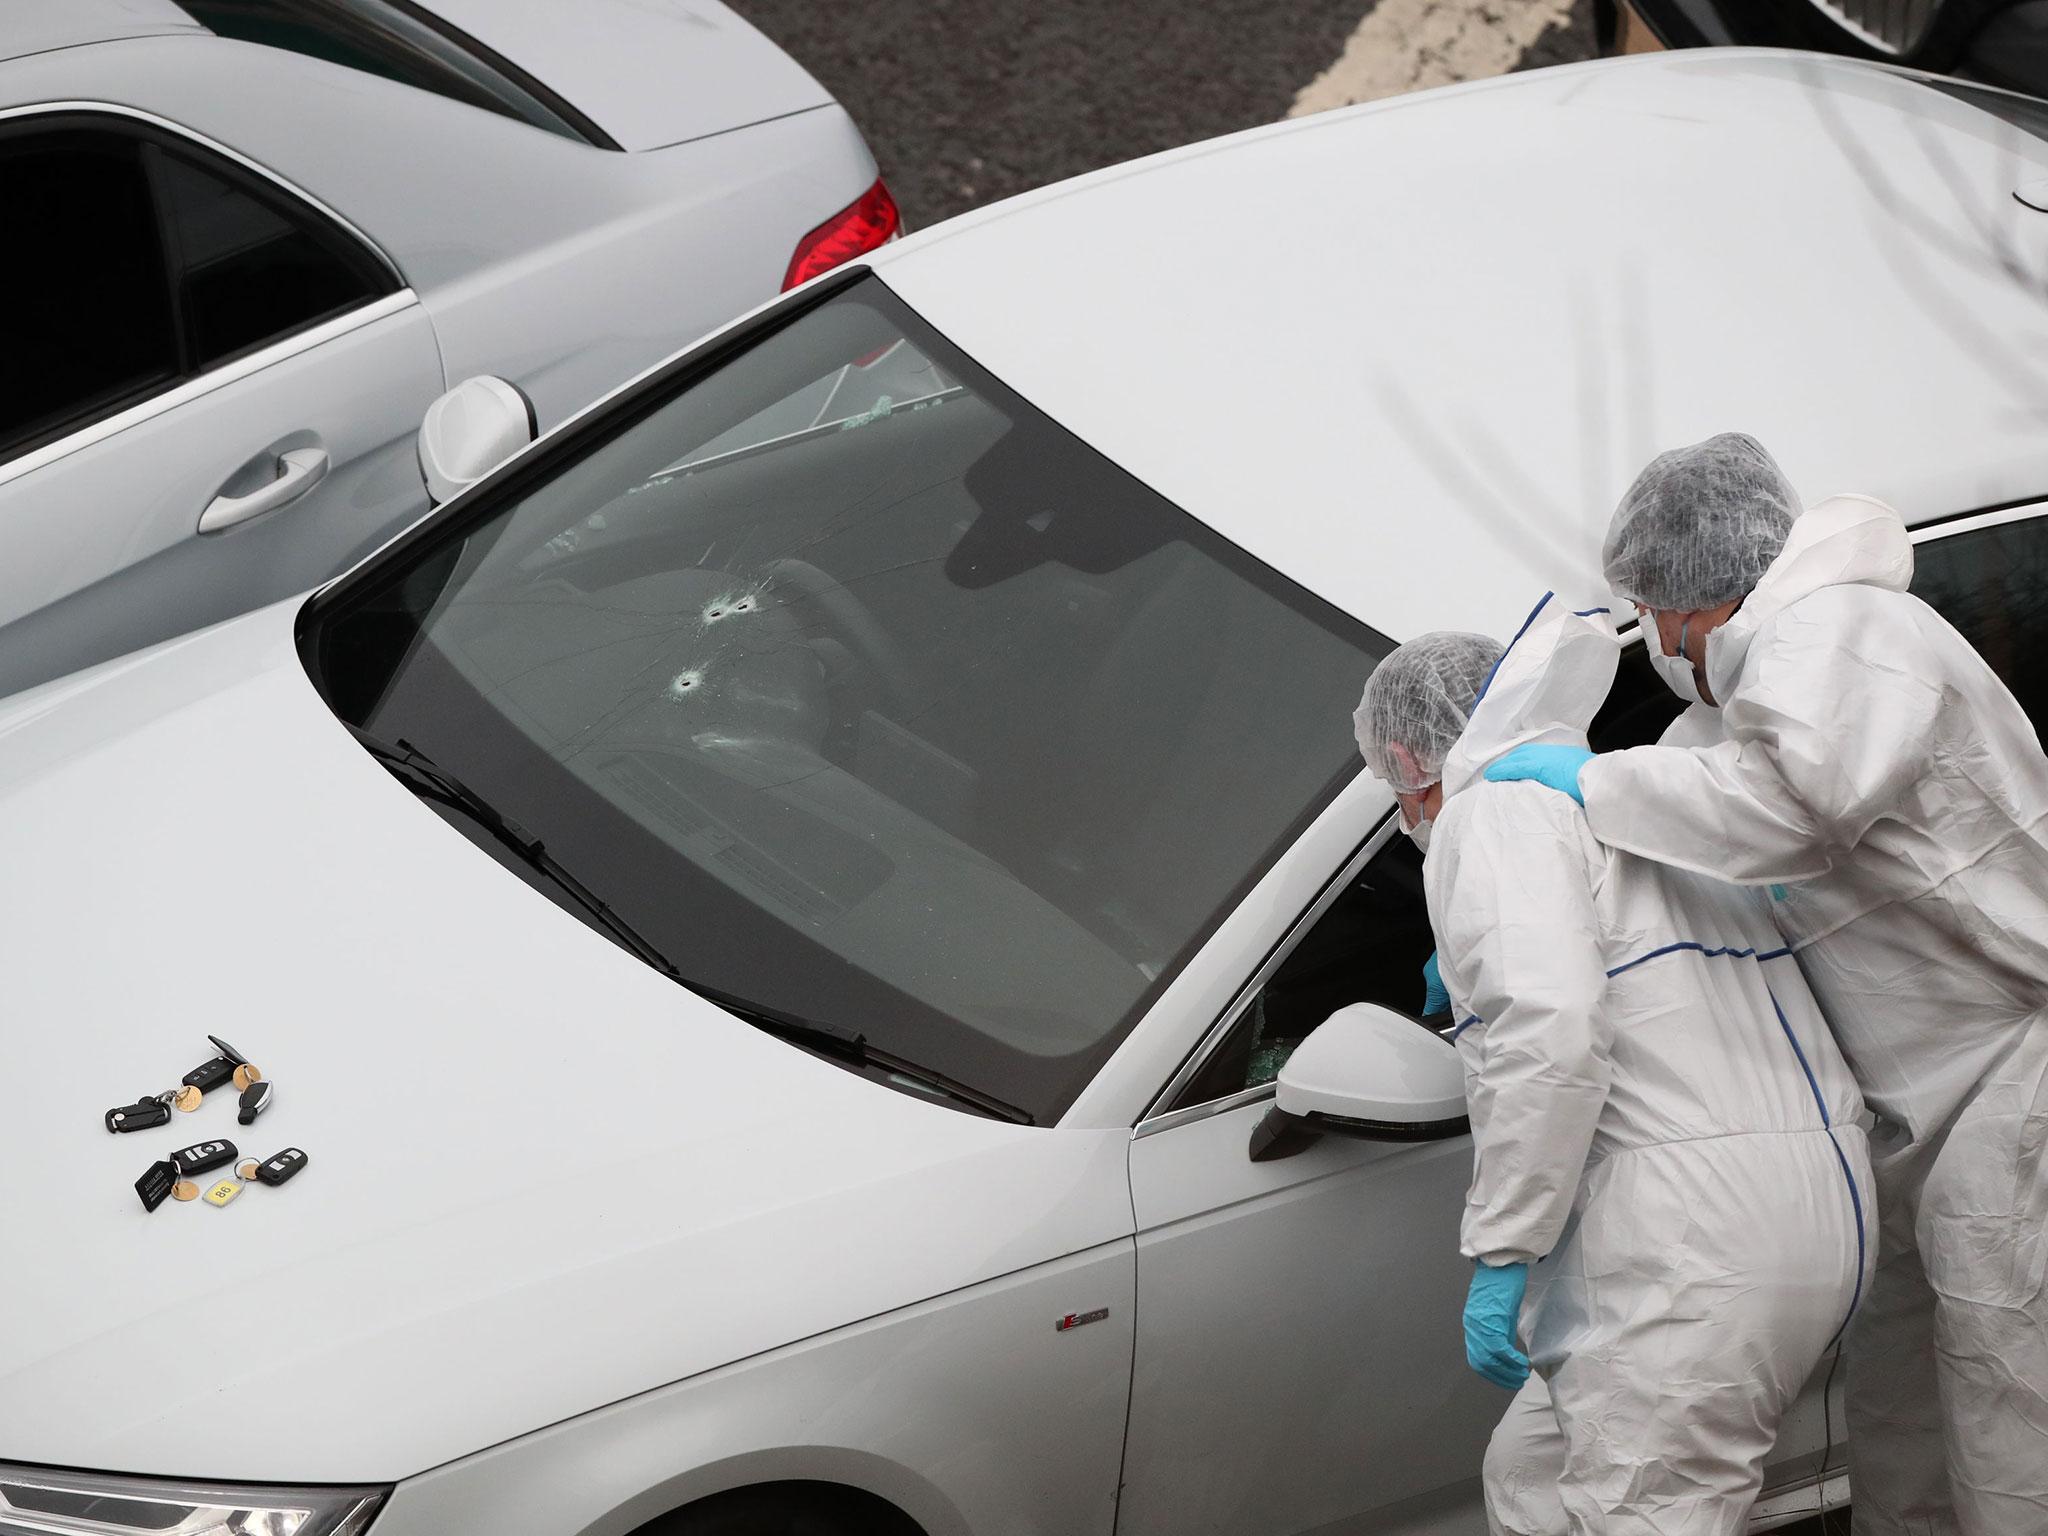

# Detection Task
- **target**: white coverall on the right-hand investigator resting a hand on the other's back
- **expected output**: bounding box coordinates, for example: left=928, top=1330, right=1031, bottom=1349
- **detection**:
left=1579, top=496, right=2048, bottom=1536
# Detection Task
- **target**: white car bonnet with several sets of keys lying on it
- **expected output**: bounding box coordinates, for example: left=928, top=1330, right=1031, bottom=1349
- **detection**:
left=0, top=604, right=1130, bottom=1483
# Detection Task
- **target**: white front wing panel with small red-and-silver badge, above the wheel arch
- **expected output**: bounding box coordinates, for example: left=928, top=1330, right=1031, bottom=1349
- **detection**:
left=377, top=1241, right=1133, bottom=1536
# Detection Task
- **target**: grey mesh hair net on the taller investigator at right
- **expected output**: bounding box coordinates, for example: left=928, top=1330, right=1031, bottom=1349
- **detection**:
left=1599, top=432, right=1800, bottom=612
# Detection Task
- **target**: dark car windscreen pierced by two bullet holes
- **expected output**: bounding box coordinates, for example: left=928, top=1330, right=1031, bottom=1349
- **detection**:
left=301, top=274, right=1391, bottom=1122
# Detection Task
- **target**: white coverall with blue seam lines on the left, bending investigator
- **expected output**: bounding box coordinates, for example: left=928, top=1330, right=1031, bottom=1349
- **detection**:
left=1423, top=598, right=1870, bottom=1536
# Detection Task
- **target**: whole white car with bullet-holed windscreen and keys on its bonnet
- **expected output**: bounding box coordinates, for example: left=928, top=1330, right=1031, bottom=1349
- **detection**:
left=0, top=41, right=2048, bottom=1536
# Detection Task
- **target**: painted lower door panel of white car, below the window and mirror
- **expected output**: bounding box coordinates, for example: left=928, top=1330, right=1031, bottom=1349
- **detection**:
left=1118, top=1100, right=1501, bottom=1536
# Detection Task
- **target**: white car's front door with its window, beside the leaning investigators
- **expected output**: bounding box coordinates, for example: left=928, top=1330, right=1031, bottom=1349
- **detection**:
left=1118, top=821, right=1507, bottom=1536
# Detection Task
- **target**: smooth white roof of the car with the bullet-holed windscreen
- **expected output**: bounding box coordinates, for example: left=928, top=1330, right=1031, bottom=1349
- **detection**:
left=874, top=49, right=2048, bottom=639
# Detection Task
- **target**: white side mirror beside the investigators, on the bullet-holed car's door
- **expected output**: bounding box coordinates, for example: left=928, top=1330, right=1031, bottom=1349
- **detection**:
left=1249, top=1004, right=1473, bottom=1163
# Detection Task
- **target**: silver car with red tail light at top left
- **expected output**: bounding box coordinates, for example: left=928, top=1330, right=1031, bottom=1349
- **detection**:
left=0, top=0, right=897, bottom=692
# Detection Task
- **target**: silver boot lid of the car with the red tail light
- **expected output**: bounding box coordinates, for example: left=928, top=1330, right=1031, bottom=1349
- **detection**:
left=430, top=0, right=831, bottom=150
